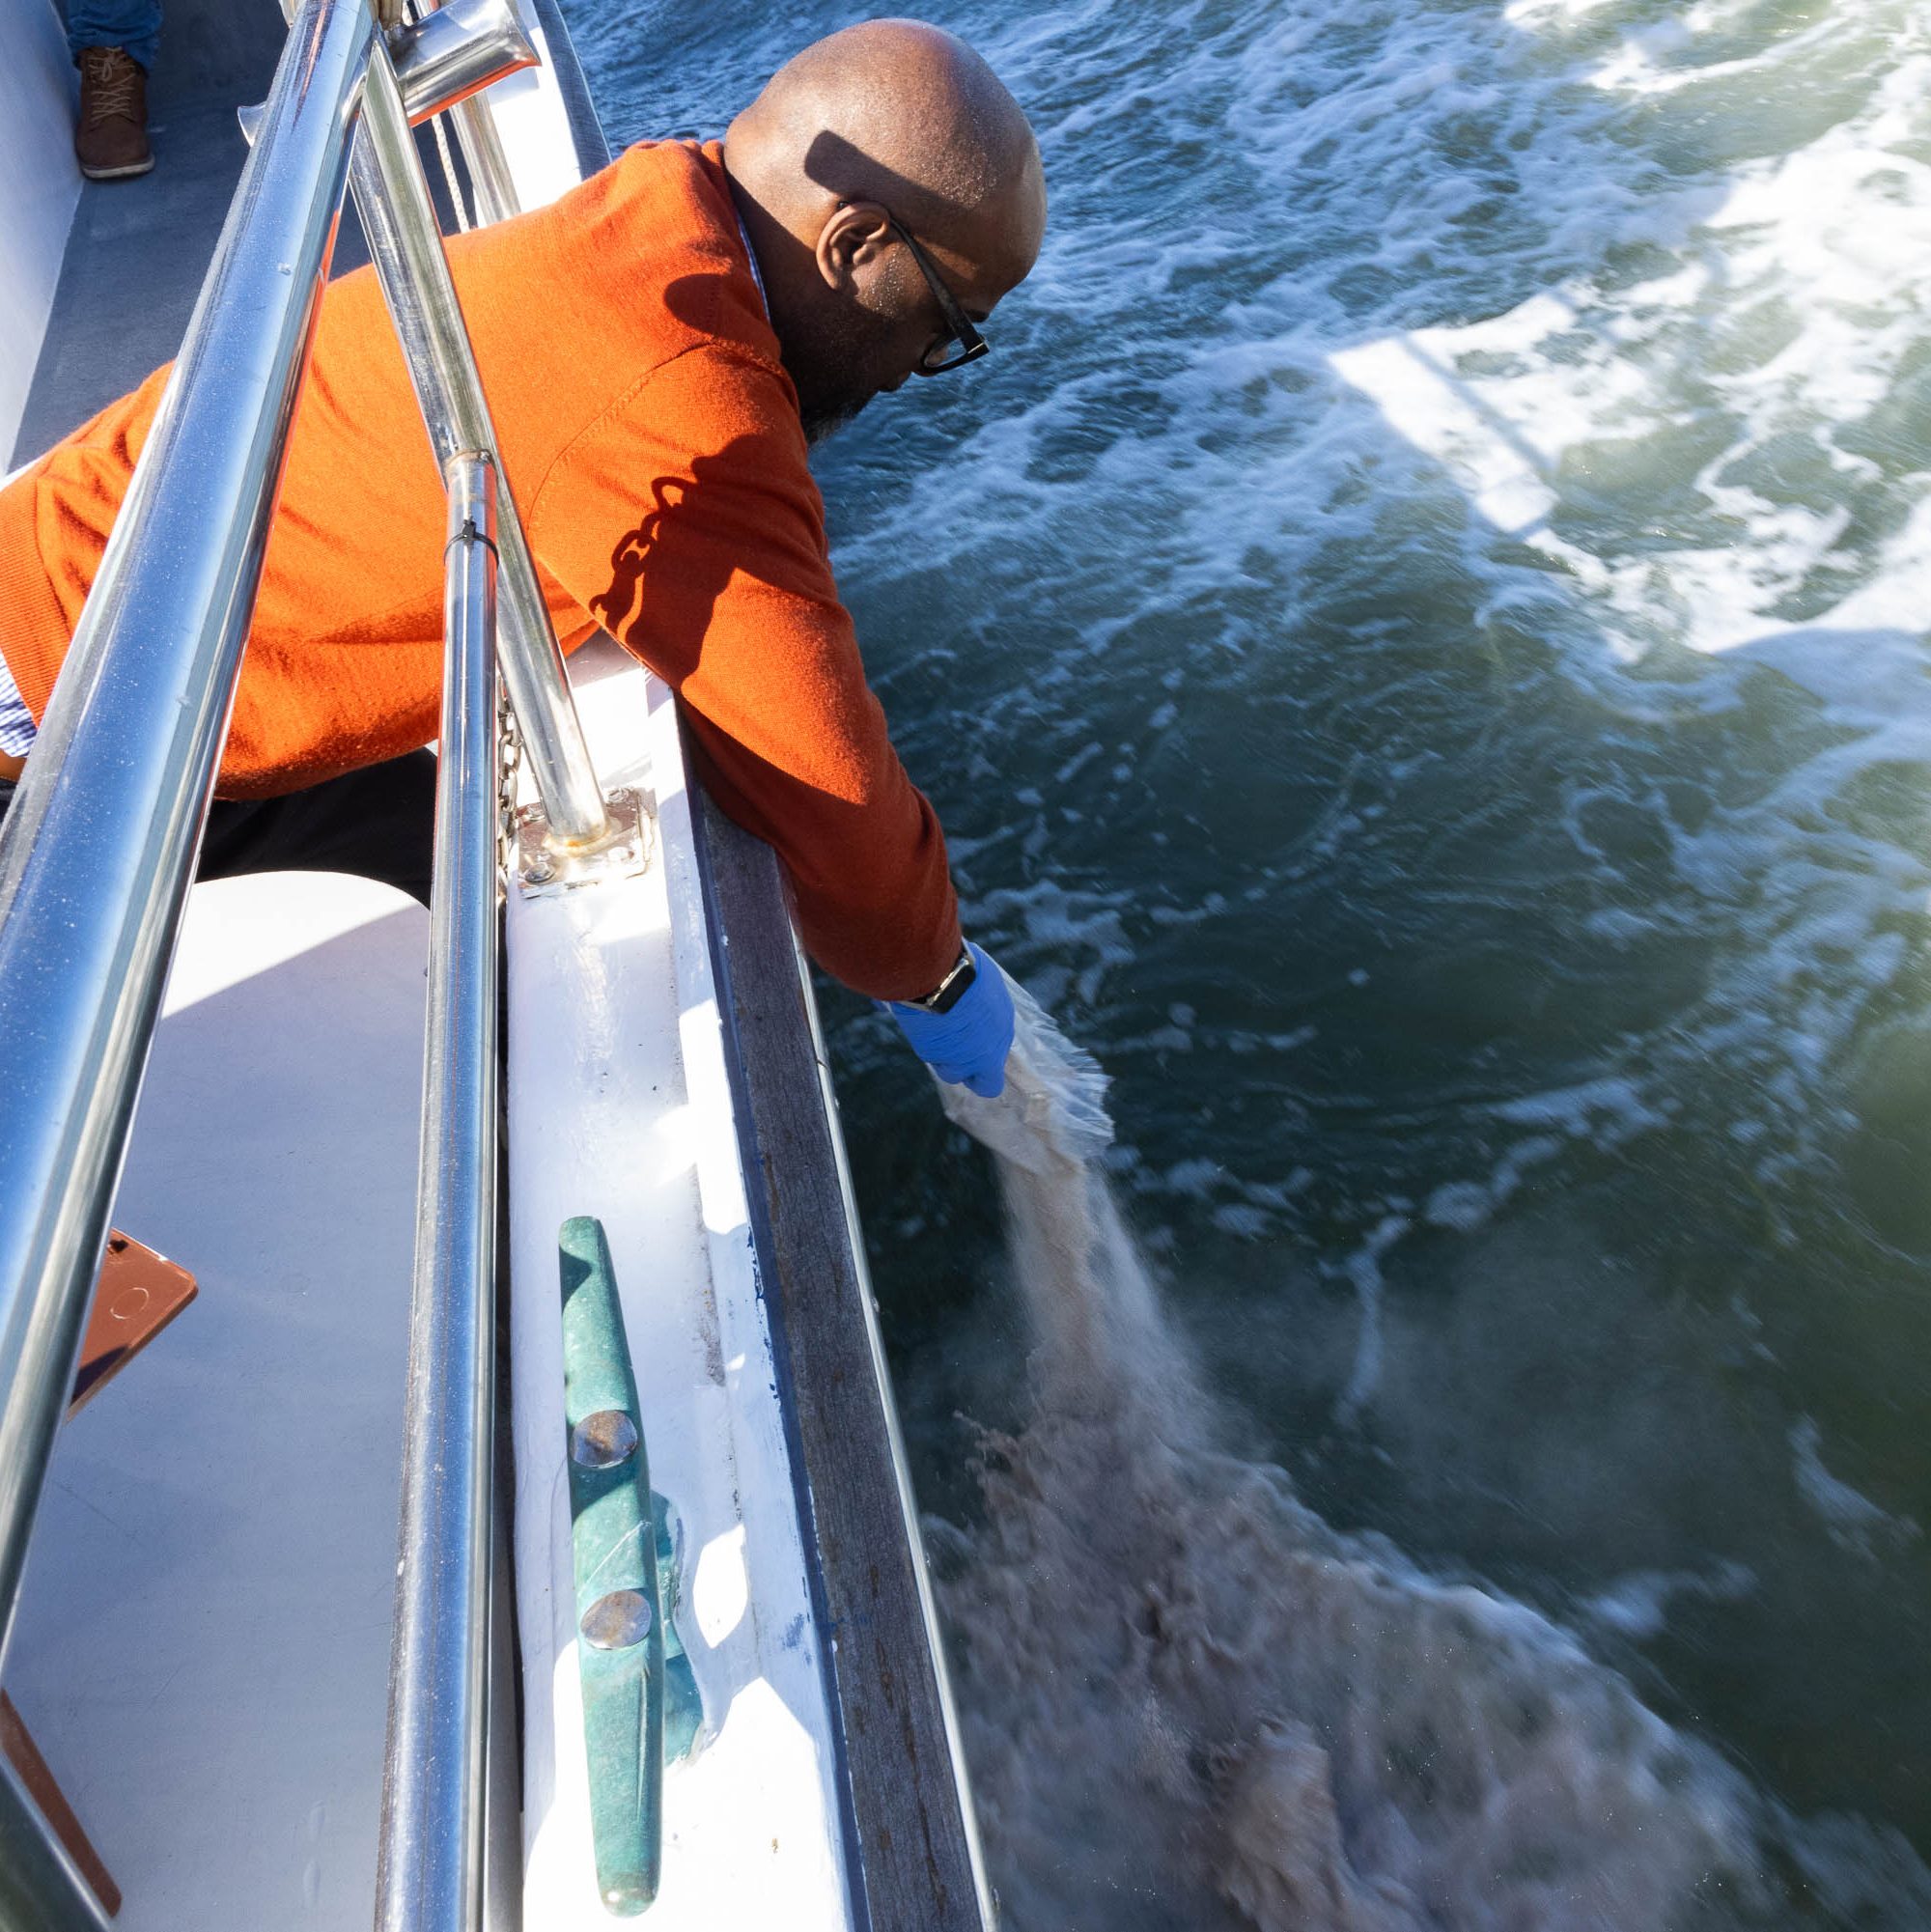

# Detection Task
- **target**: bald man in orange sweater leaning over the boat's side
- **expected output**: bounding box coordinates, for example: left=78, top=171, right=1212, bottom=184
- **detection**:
left=0, top=21, right=1045, bottom=1094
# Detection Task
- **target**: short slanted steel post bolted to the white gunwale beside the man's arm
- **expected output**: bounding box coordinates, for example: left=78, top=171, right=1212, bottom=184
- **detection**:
left=350, top=30, right=612, bottom=846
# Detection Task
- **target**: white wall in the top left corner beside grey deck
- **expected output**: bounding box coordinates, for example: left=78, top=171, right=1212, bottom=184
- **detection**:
left=0, top=0, right=81, bottom=469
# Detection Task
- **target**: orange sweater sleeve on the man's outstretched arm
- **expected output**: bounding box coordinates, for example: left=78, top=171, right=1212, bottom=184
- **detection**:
left=529, top=346, right=960, bottom=999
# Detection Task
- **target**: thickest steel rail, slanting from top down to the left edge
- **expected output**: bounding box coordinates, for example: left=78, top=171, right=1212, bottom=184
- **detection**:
left=0, top=0, right=375, bottom=1676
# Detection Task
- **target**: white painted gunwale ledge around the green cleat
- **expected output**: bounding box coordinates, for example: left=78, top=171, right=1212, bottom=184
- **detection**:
left=508, top=645, right=848, bottom=1932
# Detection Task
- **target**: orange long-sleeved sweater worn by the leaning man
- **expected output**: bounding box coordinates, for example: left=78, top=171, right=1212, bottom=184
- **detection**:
left=0, top=141, right=960, bottom=999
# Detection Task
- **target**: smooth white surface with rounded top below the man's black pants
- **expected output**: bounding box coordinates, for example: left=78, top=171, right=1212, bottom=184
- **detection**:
left=6, top=873, right=429, bottom=1932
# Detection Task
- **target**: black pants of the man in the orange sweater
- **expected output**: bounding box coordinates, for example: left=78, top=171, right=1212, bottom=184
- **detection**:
left=0, top=751, right=436, bottom=906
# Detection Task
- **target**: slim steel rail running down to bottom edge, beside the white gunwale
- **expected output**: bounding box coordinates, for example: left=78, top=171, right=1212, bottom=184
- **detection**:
left=375, top=450, right=498, bottom=1932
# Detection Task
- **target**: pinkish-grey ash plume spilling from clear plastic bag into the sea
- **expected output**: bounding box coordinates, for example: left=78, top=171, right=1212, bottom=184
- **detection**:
left=935, top=994, right=1931, bottom=1932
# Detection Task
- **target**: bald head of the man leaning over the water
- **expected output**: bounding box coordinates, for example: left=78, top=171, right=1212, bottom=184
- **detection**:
left=724, top=19, right=1047, bottom=442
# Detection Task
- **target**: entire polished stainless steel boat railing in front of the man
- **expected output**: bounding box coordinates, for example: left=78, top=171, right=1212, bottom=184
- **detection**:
left=0, top=0, right=614, bottom=1932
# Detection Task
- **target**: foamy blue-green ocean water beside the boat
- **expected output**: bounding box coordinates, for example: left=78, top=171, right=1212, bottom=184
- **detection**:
left=574, top=0, right=1931, bottom=1932
